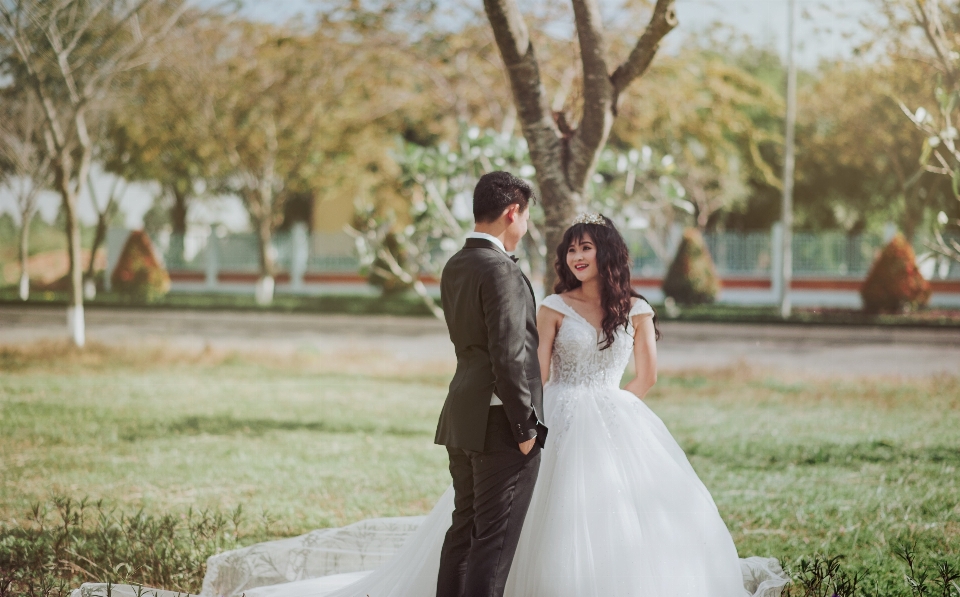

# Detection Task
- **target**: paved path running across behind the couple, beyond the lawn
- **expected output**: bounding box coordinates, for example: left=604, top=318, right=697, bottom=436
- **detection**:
left=0, top=307, right=960, bottom=377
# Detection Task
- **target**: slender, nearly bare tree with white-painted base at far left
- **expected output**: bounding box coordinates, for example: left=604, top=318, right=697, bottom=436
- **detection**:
left=0, top=0, right=186, bottom=346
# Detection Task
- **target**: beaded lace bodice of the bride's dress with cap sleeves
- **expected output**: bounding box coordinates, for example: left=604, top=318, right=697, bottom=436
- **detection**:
left=542, top=294, right=653, bottom=388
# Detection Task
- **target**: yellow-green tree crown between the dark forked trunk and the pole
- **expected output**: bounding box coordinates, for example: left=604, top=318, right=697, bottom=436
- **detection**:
left=611, top=44, right=783, bottom=231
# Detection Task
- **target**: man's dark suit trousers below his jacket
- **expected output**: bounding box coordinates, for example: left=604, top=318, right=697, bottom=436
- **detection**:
left=437, top=406, right=541, bottom=597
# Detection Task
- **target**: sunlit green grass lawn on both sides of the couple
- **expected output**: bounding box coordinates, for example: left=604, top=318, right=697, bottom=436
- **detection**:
left=0, top=345, right=960, bottom=595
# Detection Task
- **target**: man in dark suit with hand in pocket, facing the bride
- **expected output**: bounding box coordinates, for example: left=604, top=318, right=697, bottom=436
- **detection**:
left=434, top=172, right=547, bottom=597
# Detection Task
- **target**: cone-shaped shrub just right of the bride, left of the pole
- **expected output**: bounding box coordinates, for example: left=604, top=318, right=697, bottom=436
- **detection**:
left=663, top=228, right=720, bottom=305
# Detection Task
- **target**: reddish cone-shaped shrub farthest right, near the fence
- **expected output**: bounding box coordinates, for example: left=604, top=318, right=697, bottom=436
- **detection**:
left=860, top=234, right=930, bottom=313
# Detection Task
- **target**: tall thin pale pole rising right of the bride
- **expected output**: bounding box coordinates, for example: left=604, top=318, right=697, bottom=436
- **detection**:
left=779, top=0, right=797, bottom=319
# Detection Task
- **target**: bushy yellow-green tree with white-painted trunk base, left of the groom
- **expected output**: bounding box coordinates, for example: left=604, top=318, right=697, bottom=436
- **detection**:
left=184, top=15, right=414, bottom=302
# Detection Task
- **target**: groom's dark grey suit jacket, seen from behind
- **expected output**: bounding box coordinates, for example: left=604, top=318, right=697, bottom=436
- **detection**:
left=434, top=238, right=547, bottom=452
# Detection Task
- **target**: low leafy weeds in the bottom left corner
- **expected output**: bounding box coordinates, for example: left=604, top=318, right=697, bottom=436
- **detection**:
left=0, top=496, right=255, bottom=597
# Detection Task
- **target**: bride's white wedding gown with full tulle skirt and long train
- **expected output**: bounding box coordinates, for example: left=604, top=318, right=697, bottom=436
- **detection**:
left=73, top=295, right=788, bottom=597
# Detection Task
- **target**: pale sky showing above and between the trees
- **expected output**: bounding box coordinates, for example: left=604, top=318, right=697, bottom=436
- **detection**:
left=0, top=0, right=873, bottom=230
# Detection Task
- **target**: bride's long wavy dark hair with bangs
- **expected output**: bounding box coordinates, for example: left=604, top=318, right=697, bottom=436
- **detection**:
left=553, top=216, right=660, bottom=350
